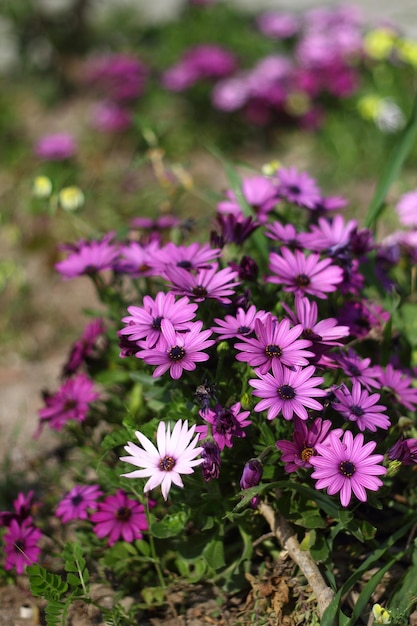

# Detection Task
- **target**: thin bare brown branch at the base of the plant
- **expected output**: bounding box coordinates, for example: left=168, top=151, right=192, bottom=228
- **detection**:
left=258, top=502, right=334, bottom=617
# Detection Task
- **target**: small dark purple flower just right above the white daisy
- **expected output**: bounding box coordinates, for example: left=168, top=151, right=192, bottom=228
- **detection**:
left=196, top=402, right=252, bottom=450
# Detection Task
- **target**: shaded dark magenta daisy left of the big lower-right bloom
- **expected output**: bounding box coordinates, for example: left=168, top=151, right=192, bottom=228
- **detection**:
left=276, top=417, right=343, bottom=473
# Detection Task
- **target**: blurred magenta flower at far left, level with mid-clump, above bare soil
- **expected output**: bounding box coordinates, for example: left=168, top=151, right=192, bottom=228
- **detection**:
left=39, top=374, right=99, bottom=430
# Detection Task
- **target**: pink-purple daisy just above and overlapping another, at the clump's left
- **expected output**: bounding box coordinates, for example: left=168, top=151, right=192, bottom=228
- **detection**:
left=118, top=291, right=198, bottom=348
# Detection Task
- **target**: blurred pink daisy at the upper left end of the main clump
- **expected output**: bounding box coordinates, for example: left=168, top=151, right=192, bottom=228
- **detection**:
left=55, top=235, right=119, bottom=279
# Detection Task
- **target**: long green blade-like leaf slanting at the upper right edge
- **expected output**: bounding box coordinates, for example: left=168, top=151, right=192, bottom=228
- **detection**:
left=365, top=94, right=417, bottom=228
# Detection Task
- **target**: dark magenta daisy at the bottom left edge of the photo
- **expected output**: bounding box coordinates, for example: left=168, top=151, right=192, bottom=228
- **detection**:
left=3, top=519, right=42, bottom=574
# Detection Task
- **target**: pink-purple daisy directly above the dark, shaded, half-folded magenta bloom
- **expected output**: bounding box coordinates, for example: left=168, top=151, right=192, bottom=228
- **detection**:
left=249, top=361, right=326, bottom=420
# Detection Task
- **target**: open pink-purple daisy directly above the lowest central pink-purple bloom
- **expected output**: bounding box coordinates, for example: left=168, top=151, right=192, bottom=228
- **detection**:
left=235, top=314, right=314, bottom=374
